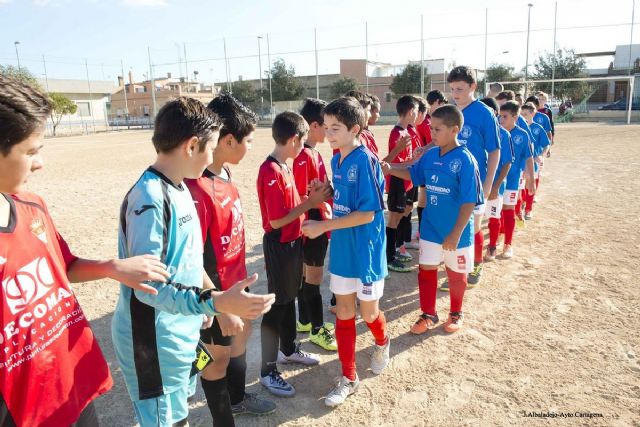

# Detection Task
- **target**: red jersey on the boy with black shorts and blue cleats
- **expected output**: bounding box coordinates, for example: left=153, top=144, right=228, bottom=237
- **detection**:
left=257, top=156, right=304, bottom=243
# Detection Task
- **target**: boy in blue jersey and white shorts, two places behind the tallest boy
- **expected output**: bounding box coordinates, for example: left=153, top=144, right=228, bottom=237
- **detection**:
left=500, top=101, right=535, bottom=258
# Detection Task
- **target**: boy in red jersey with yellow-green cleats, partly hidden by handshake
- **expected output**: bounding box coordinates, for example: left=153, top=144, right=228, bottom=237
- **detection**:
left=293, top=98, right=337, bottom=351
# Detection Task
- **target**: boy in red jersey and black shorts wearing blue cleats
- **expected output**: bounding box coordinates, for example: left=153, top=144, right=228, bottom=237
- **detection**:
left=257, top=111, right=331, bottom=397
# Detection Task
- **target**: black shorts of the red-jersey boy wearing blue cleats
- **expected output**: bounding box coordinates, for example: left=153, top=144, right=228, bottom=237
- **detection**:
left=262, top=230, right=303, bottom=304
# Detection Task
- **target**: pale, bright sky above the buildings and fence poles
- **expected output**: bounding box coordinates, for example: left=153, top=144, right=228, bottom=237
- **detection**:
left=0, top=0, right=640, bottom=82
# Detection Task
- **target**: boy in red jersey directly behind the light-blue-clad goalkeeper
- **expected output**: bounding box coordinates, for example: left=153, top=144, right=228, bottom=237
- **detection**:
left=185, top=93, right=276, bottom=426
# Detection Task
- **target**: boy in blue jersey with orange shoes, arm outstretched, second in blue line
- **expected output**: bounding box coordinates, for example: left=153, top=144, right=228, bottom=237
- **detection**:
left=383, top=105, right=484, bottom=334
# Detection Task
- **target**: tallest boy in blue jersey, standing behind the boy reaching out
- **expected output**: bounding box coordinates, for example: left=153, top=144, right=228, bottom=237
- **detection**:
left=442, top=66, right=500, bottom=290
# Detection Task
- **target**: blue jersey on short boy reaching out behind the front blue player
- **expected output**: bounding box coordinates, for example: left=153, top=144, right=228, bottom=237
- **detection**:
left=409, top=146, right=484, bottom=248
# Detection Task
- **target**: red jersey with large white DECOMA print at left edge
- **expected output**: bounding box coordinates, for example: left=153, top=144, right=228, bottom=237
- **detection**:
left=0, top=193, right=113, bottom=427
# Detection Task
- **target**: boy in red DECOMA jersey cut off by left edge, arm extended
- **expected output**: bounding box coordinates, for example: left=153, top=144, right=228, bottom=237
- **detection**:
left=0, top=75, right=169, bottom=427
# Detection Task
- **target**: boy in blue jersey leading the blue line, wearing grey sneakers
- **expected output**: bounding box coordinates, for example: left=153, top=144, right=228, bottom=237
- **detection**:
left=302, top=97, right=390, bottom=407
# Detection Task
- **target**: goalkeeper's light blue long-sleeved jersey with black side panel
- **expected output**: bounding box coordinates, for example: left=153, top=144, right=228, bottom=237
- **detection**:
left=111, top=168, right=214, bottom=401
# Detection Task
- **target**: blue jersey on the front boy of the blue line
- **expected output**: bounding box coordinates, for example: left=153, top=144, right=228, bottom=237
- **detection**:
left=329, top=145, right=387, bottom=283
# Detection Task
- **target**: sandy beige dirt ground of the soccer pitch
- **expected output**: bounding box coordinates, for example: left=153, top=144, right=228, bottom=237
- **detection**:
left=29, top=124, right=640, bottom=427
